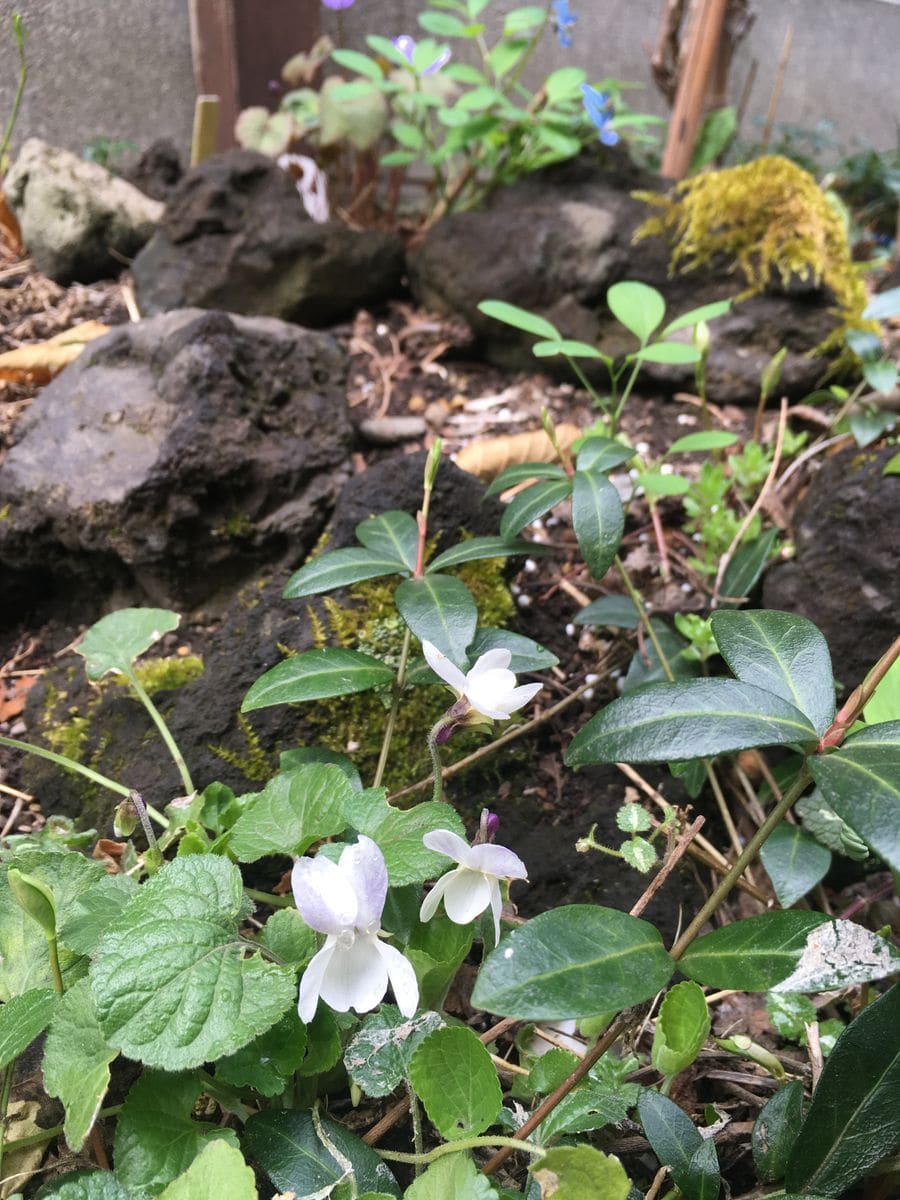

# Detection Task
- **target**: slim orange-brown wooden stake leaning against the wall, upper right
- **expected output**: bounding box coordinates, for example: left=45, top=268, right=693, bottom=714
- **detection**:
left=660, top=0, right=727, bottom=179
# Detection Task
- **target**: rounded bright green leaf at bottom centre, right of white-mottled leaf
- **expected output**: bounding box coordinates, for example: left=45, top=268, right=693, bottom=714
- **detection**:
left=409, top=1026, right=503, bottom=1141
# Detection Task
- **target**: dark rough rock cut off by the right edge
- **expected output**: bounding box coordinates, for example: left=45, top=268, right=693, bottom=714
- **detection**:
left=763, top=446, right=900, bottom=688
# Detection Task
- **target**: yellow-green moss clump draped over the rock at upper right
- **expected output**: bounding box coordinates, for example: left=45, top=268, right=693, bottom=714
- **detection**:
left=635, top=155, right=875, bottom=353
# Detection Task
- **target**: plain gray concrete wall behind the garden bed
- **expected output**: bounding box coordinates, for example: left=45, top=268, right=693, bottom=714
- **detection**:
left=0, top=0, right=900, bottom=164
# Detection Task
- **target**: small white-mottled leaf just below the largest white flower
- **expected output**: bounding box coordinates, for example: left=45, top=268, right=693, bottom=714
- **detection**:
left=343, top=1004, right=444, bottom=1097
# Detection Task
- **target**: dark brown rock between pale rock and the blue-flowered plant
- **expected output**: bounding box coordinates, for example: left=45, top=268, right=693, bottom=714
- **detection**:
left=132, top=150, right=403, bottom=326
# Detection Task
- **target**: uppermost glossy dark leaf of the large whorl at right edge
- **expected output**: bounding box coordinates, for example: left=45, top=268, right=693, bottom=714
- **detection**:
left=712, top=610, right=834, bottom=734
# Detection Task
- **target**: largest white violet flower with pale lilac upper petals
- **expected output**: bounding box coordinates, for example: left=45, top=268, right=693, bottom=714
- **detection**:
left=296, top=836, right=419, bottom=1025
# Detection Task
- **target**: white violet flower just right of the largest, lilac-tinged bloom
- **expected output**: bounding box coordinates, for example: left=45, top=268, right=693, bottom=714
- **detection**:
left=419, top=829, right=528, bottom=942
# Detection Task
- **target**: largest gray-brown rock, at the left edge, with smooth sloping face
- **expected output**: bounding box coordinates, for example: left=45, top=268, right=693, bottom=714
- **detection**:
left=0, top=310, right=350, bottom=608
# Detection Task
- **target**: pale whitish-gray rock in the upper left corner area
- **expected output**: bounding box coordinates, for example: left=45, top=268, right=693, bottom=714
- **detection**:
left=4, top=138, right=163, bottom=283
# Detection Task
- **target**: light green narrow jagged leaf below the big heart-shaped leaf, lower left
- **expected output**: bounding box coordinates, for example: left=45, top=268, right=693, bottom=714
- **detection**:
left=43, top=978, right=118, bottom=1151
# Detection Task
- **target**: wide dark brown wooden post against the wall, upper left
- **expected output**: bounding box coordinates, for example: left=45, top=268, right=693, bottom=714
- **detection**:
left=190, top=0, right=322, bottom=150
